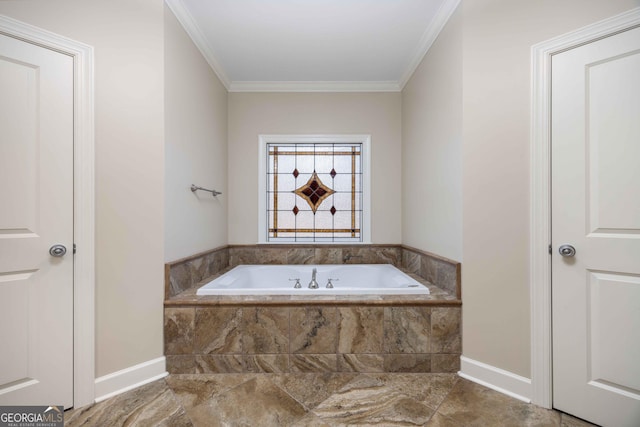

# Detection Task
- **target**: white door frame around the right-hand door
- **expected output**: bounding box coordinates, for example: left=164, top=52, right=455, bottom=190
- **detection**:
left=529, top=7, right=640, bottom=408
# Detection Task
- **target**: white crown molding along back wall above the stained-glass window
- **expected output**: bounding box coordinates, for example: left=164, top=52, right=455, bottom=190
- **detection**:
left=229, top=81, right=401, bottom=92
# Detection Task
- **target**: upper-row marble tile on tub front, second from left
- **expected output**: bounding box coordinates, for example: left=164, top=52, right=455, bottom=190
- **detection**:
left=194, top=307, right=242, bottom=354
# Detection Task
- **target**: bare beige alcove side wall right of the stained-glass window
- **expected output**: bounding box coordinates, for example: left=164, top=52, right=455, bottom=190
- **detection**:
left=402, top=7, right=462, bottom=261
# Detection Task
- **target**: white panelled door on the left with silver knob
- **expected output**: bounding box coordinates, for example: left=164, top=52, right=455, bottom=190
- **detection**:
left=0, top=30, right=73, bottom=407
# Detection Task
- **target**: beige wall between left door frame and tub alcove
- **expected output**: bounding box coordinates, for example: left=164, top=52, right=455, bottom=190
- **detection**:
left=0, top=0, right=164, bottom=376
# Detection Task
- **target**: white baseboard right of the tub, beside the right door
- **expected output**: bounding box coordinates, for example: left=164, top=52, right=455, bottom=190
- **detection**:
left=458, top=356, right=532, bottom=403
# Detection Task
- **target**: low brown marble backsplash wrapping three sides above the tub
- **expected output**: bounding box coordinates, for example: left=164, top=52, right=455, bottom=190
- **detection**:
left=165, top=245, right=461, bottom=299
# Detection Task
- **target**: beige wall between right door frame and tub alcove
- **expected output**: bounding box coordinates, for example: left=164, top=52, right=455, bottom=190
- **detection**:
left=462, top=0, right=638, bottom=377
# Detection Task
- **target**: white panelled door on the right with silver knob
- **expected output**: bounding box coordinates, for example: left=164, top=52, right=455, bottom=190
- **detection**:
left=551, top=28, right=640, bottom=427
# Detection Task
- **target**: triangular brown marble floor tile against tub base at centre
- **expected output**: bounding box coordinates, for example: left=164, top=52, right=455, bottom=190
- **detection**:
left=271, top=373, right=358, bottom=409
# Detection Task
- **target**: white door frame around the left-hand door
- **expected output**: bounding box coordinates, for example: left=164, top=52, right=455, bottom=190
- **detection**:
left=0, top=15, right=95, bottom=408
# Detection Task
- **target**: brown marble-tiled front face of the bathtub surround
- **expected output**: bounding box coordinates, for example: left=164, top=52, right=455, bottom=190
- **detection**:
left=164, top=304, right=462, bottom=374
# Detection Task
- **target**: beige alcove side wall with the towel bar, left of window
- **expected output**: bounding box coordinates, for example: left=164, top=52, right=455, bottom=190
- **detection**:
left=164, top=6, right=228, bottom=261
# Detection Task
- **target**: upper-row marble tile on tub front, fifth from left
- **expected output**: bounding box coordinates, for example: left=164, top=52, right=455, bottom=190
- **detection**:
left=338, top=307, right=384, bottom=353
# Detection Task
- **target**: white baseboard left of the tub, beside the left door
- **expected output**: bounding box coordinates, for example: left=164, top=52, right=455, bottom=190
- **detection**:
left=95, top=356, right=168, bottom=402
